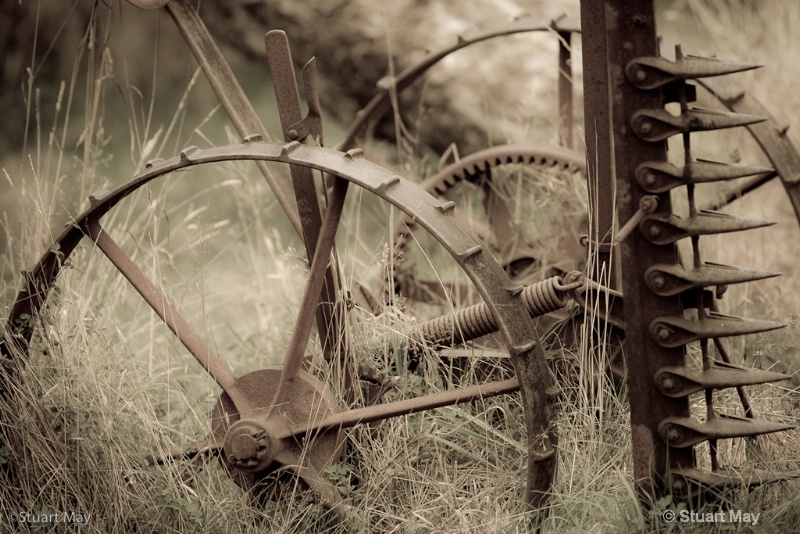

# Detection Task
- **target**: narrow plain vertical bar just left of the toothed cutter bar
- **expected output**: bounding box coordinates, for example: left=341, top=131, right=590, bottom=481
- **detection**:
left=581, top=0, right=619, bottom=289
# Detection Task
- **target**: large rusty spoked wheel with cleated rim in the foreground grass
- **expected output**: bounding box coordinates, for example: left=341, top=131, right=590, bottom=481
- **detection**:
left=2, top=141, right=556, bottom=509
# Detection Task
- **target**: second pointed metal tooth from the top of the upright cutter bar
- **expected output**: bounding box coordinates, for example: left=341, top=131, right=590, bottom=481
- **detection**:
left=631, top=108, right=767, bottom=142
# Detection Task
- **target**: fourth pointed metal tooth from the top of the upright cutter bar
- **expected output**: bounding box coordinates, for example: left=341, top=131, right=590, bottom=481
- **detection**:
left=639, top=210, right=775, bottom=245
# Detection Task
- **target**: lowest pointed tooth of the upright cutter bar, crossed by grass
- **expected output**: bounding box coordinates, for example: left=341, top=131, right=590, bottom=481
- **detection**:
left=671, top=467, right=800, bottom=499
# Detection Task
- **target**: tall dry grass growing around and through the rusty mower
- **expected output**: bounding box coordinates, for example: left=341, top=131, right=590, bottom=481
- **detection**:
left=0, top=2, right=800, bottom=533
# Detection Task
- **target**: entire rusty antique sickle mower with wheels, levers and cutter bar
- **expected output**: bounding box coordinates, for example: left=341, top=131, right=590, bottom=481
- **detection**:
left=7, top=0, right=800, bottom=507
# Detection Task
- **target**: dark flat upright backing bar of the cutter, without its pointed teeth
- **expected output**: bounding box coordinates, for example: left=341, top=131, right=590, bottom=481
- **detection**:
left=600, top=0, right=694, bottom=499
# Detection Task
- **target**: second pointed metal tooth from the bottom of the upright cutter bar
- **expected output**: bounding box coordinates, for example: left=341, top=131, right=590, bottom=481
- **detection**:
left=658, top=415, right=793, bottom=448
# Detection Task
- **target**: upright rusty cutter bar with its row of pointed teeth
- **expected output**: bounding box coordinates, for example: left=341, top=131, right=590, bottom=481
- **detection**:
left=606, top=1, right=790, bottom=499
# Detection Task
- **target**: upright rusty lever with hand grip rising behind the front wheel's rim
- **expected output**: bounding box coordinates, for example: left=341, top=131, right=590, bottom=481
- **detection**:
left=264, top=30, right=349, bottom=370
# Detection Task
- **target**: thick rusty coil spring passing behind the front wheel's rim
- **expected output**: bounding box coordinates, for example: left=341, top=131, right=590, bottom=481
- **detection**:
left=419, top=276, right=572, bottom=345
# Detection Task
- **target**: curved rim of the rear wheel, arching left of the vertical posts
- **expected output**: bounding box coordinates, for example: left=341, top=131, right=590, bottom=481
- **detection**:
left=336, top=17, right=581, bottom=150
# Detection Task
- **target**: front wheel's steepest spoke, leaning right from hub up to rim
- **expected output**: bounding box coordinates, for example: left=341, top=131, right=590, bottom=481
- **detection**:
left=272, top=178, right=350, bottom=407
